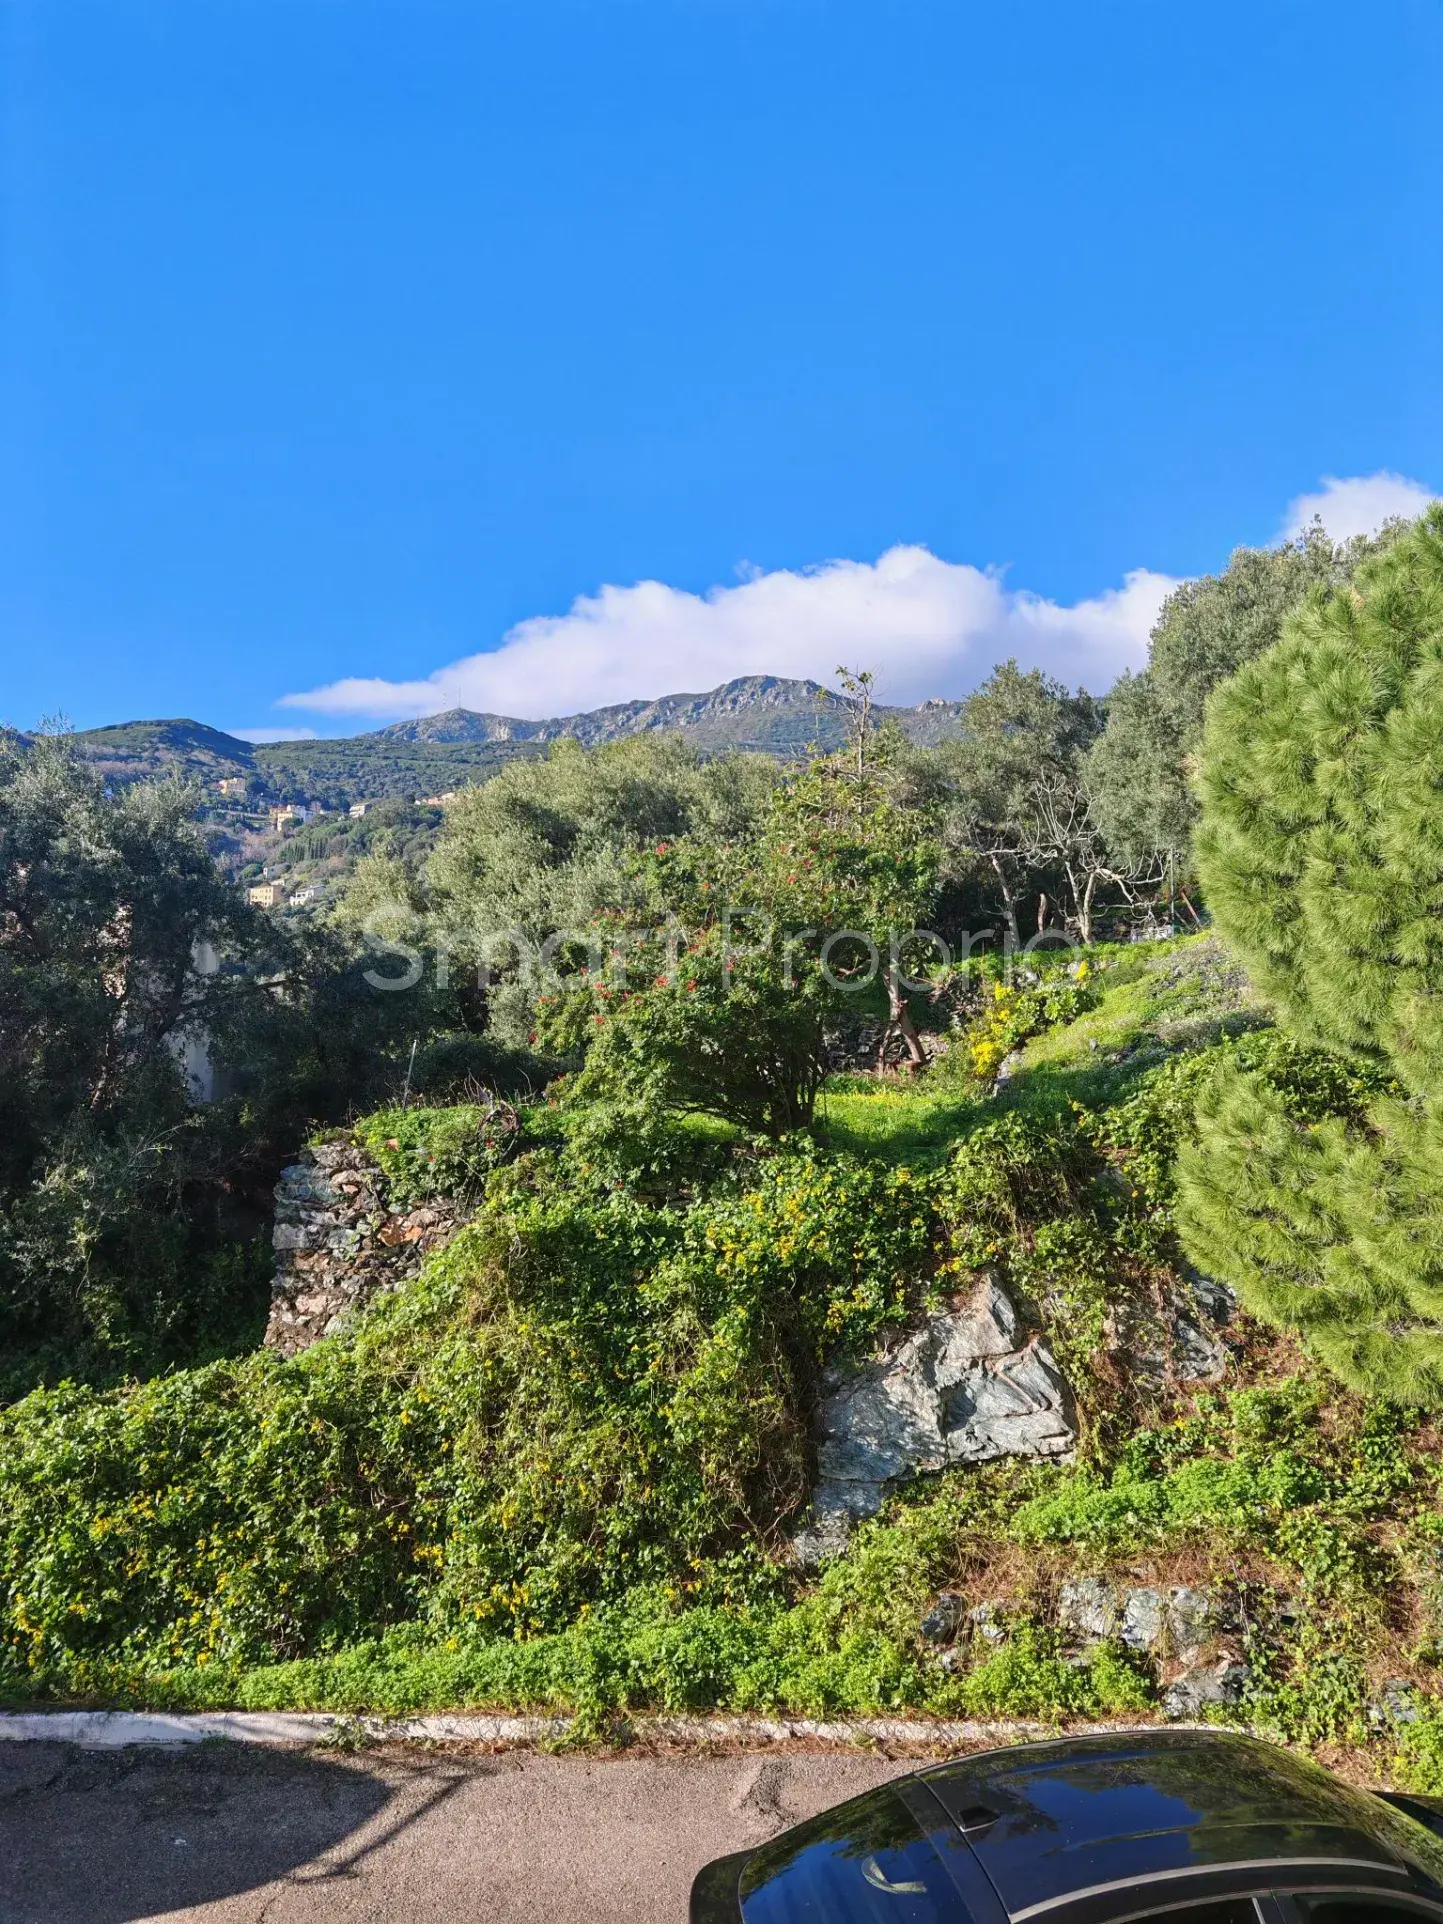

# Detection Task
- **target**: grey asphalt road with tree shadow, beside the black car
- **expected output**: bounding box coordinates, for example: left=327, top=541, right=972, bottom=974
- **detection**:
left=0, top=1743, right=914, bottom=1924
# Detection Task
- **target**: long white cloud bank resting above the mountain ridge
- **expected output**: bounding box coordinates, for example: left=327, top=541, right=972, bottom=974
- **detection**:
left=283, top=546, right=1176, bottom=720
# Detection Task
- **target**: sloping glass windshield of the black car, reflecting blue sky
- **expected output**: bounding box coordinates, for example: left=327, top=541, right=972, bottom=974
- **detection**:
left=741, top=1791, right=972, bottom=1924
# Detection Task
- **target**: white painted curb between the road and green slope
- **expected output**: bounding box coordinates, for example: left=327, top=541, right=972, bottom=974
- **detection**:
left=0, top=1710, right=1162, bottom=1751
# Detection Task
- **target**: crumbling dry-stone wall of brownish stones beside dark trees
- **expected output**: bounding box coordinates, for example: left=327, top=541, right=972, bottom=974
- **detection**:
left=266, top=1143, right=462, bottom=1356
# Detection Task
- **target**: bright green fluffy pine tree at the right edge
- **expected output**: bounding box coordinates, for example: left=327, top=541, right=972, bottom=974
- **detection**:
left=1179, top=504, right=1443, bottom=1403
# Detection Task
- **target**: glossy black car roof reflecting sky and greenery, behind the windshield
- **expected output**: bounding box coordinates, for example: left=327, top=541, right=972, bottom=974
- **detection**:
left=924, top=1732, right=1443, bottom=1924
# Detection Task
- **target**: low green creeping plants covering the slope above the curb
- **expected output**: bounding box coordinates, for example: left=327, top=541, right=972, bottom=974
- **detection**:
left=0, top=939, right=1443, bottom=1782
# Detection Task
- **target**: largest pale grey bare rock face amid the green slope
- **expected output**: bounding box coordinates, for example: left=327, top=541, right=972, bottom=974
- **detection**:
left=793, top=1278, right=1077, bottom=1564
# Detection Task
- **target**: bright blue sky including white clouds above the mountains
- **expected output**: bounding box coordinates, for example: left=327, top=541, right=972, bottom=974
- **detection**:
left=0, top=0, right=1443, bottom=733
